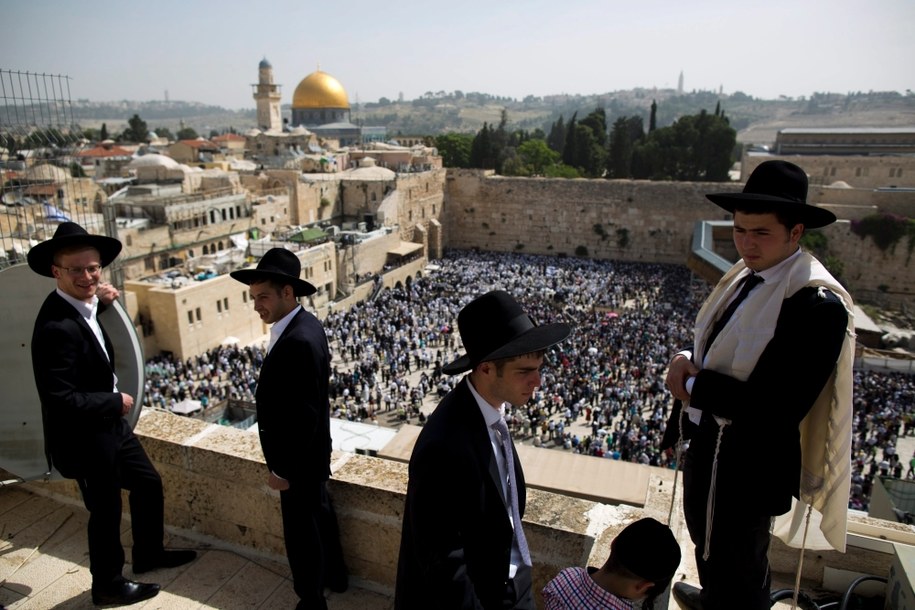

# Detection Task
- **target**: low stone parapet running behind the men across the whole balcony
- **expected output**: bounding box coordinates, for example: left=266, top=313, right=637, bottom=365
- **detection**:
left=25, top=409, right=915, bottom=607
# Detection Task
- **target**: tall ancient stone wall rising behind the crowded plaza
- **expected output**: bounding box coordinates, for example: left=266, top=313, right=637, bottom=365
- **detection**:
left=442, top=170, right=733, bottom=263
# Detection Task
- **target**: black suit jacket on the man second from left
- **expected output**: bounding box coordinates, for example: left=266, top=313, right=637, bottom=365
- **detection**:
left=255, top=309, right=332, bottom=486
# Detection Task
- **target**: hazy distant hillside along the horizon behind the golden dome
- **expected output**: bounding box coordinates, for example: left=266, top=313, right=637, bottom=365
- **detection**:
left=12, top=88, right=915, bottom=153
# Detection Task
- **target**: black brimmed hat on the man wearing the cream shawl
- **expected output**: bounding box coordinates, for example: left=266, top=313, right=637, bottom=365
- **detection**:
left=706, top=160, right=836, bottom=229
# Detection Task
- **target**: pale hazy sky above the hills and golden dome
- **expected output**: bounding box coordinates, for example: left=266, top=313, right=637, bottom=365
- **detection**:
left=7, top=0, right=915, bottom=109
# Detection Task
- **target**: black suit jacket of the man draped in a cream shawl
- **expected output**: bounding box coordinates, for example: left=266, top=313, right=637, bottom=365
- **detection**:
left=662, top=287, right=848, bottom=515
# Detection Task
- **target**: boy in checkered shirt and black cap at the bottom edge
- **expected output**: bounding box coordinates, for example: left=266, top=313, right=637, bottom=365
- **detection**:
left=543, top=517, right=680, bottom=610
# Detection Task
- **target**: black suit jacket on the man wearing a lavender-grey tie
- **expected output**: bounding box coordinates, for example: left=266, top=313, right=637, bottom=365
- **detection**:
left=394, top=377, right=525, bottom=610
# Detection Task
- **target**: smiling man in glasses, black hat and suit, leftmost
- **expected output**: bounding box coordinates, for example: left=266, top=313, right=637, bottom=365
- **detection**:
left=28, top=222, right=197, bottom=605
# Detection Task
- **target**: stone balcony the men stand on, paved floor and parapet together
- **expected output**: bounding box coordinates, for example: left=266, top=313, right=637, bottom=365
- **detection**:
left=0, top=410, right=915, bottom=610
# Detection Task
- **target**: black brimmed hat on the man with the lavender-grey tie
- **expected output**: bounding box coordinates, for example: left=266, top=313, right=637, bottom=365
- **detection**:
left=442, top=290, right=572, bottom=375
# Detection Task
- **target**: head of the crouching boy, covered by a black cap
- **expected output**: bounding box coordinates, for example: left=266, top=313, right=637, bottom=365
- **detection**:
left=603, top=517, right=680, bottom=599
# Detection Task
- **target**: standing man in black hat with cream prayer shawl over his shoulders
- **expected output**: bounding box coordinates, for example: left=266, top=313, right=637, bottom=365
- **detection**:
left=662, top=161, right=854, bottom=610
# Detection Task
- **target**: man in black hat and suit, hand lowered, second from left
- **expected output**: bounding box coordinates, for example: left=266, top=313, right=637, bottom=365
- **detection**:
left=230, top=248, right=348, bottom=610
